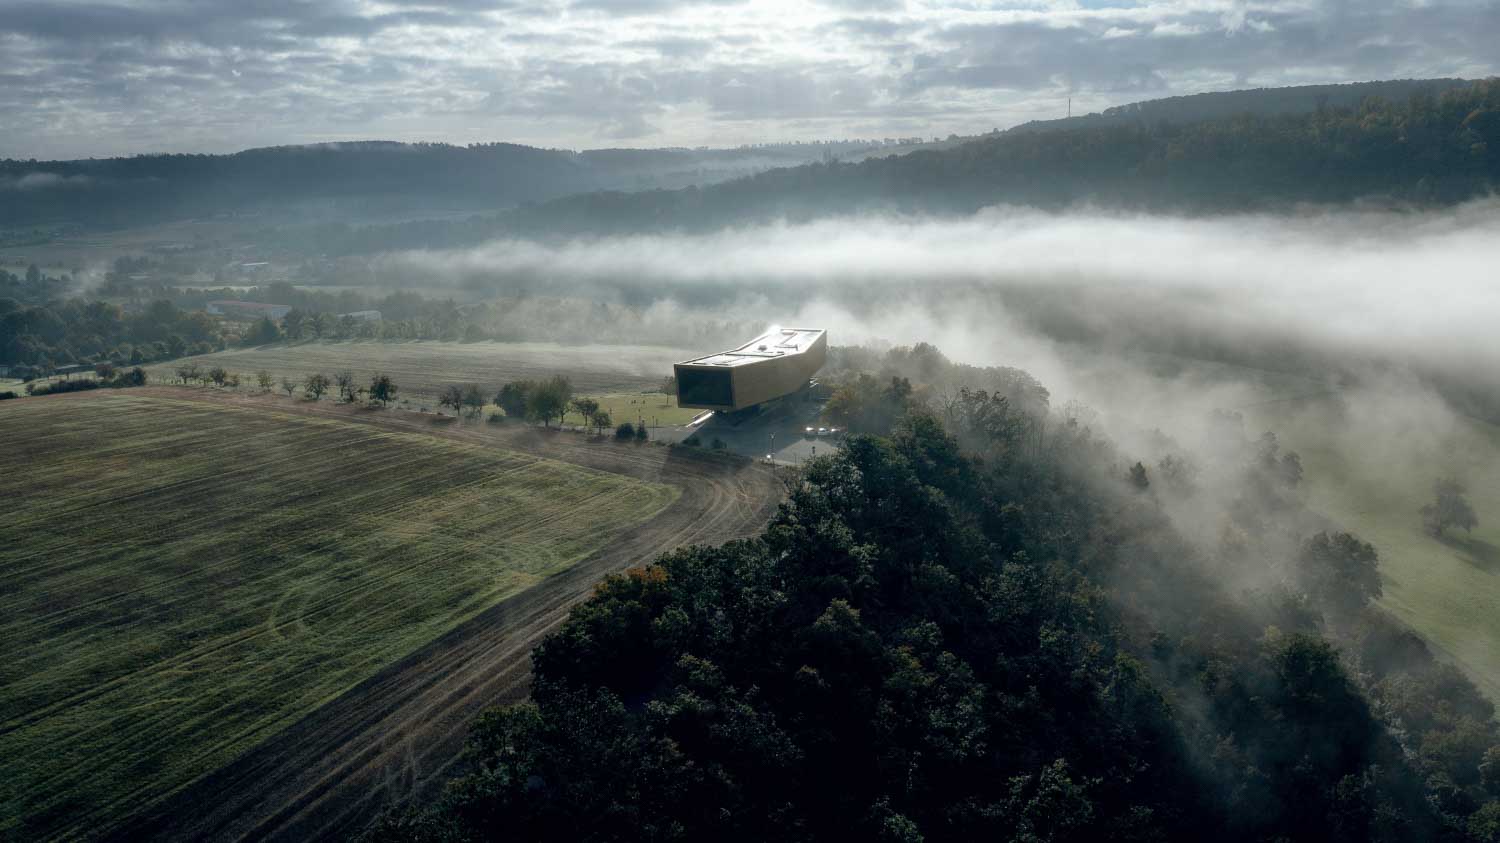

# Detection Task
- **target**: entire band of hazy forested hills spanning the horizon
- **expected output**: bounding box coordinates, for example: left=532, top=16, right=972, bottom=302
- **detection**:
left=0, top=80, right=1496, bottom=237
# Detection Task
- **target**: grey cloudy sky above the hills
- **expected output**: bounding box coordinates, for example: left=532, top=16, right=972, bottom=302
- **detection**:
left=0, top=0, right=1500, bottom=159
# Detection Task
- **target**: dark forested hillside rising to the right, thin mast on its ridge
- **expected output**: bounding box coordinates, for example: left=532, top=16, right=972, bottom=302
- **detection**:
left=298, top=80, right=1500, bottom=254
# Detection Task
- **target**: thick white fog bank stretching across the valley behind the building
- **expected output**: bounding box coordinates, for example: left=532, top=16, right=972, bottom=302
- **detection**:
left=375, top=200, right=1500, bottom=416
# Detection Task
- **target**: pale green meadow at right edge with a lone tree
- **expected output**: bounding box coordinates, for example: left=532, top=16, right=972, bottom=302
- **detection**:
left=1250, top=396, right=1500, bottom=702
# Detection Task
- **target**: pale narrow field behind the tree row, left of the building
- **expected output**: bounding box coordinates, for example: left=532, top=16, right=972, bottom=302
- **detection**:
left=149, top=341, right=695, bottom=410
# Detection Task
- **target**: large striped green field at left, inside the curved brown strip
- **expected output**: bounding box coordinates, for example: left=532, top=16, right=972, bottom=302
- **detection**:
left=0, top=392, right=678, bottom=837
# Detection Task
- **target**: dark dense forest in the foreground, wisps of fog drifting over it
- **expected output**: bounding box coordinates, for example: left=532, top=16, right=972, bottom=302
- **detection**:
left=381, top=347, right=1500, bottom=842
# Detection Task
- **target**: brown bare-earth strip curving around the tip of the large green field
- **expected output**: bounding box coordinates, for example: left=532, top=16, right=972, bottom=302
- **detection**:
left=113, top=389, right=783, bottom=840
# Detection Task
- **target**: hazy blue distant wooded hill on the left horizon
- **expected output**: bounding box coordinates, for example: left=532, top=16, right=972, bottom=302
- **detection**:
left=0, top=141, right=869, bottom=227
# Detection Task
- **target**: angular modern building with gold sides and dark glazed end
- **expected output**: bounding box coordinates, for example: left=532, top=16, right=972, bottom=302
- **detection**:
left=674, top=329, right=828, bottom=413
